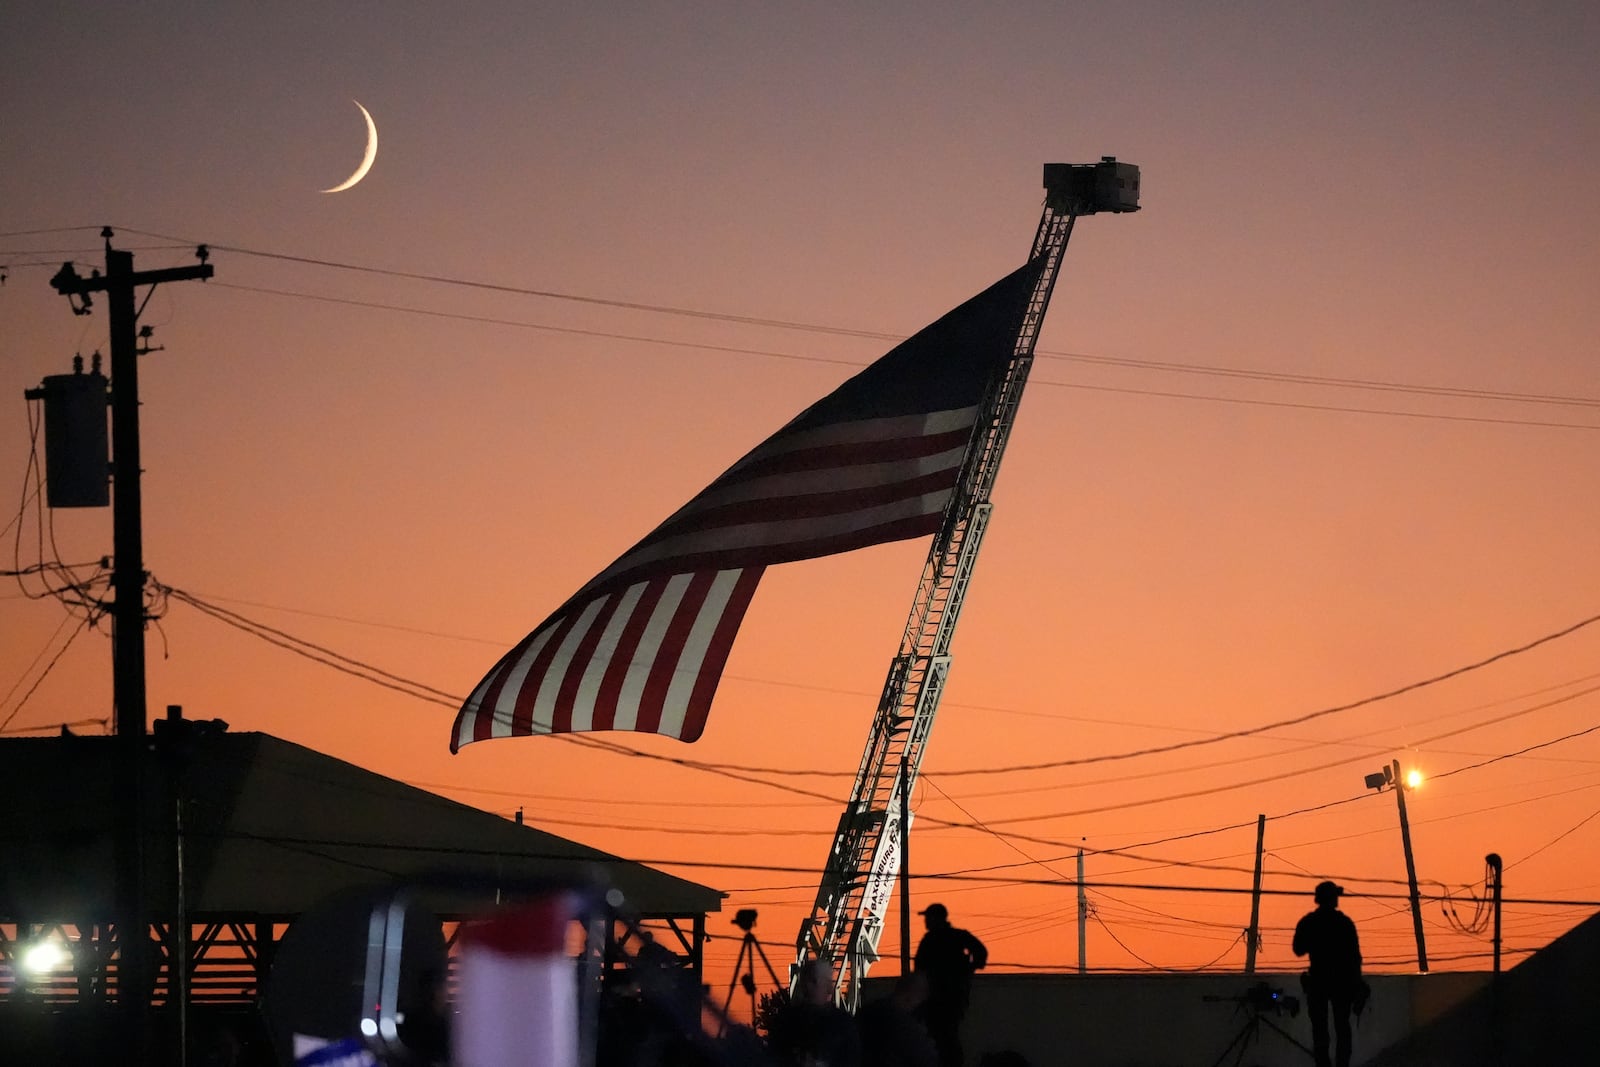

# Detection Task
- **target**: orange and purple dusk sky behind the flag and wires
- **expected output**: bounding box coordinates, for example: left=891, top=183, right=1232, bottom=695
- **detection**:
left=0, top=3, right=1600, bottom=1017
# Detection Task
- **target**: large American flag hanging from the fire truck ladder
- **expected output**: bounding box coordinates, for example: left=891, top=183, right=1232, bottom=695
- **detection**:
left=450, top=259, right=1042, bottom=752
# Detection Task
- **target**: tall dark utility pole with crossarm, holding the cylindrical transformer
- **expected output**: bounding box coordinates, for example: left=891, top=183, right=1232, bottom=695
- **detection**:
left=50, top=227, right=213, bottom=1061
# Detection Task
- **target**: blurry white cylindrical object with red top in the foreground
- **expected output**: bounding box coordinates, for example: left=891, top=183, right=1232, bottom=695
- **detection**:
left=451, top=894, right=578, bottom=1067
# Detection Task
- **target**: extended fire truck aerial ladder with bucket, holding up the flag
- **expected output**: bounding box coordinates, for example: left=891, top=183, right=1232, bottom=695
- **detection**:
left=795, top=155, right=1139, bottom=1011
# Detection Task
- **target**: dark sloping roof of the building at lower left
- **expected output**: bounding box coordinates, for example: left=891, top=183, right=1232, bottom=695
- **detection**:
left=0, top=720, right=725, bottom=921
